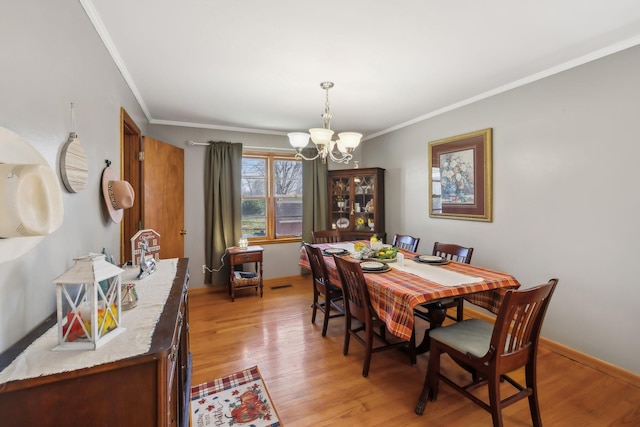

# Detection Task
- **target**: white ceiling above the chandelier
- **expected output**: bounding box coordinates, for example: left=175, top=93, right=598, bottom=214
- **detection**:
left=80, top=0, right=640, bottom=139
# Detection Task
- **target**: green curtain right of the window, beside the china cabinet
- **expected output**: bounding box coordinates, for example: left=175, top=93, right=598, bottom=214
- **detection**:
left=302, top=149, right=329, bottom=242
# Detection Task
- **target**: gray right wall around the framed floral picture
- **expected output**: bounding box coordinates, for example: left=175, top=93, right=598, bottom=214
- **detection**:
left=363, top=47, right=640, bottom=373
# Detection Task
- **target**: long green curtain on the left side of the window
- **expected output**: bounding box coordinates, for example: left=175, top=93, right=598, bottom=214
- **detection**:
left=204, top=141, right=242, bottom=285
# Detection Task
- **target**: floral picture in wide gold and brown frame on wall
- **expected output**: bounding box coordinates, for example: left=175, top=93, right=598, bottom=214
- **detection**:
left=428, top=128, right=493, bottom=222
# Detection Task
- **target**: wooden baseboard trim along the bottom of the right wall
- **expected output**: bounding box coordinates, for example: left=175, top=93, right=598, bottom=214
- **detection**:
left=464, top=307, right=640, bottom=388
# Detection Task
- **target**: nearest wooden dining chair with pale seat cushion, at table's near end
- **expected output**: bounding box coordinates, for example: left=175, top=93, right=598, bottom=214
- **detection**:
left=415, top=279, right=558, bottom=426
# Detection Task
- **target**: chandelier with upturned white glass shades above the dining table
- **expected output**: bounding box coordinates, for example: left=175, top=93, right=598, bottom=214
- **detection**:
left=287, top=82, right=362, bottom=164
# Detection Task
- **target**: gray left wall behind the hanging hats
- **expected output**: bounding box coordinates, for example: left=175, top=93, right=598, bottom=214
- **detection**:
left=0, top=0, right=146, bottom=352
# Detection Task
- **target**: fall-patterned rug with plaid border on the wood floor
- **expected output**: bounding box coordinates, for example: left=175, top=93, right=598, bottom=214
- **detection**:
left=191, top=366, right=283, bottom=427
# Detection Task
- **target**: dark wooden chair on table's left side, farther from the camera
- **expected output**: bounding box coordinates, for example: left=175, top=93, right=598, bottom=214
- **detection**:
left=303, top=243, right=344, bottom=337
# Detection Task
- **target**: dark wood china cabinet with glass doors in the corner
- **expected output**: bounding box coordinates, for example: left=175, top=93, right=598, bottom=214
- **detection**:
left=327, top=168, right=386, bottom=240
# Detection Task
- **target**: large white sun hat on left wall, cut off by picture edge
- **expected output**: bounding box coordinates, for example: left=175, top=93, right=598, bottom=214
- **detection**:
left=0, top=127, right=64, bottom=263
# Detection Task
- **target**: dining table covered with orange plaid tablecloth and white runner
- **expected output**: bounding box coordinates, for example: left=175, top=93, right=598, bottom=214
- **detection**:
left=298, top=242, right=520, bottom=354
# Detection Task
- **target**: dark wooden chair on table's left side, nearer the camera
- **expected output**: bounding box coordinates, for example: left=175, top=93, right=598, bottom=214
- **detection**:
left=334, top=256, right=416, bottom=377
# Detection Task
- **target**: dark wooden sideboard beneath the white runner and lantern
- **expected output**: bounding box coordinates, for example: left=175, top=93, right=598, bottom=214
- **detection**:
left=0, top=258, right=191, bottom=427
